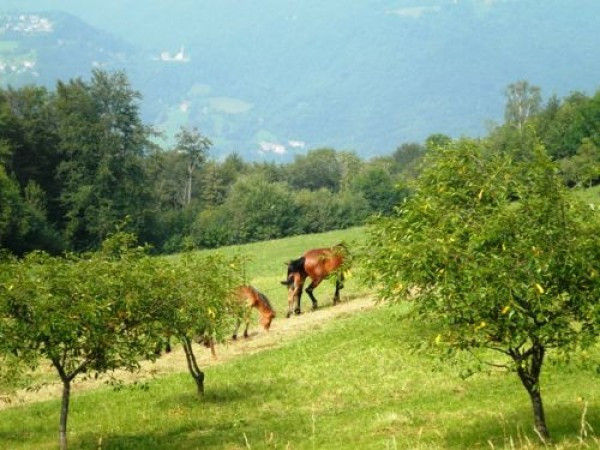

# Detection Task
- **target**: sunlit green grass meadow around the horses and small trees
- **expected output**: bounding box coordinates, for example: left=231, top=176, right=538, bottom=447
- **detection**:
left=0, top=228, right=600, bottom=449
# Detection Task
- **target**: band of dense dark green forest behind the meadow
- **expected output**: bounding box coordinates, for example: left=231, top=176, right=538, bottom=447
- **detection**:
left=0, top=74, right=600, bottom=255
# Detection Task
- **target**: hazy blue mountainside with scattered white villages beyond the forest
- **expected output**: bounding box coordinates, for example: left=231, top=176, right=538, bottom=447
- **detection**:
left=0, top=0, right=600, bottom=160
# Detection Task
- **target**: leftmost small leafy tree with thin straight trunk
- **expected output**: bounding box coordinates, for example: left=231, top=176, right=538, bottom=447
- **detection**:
left=0, top=234, right=173, bottom=449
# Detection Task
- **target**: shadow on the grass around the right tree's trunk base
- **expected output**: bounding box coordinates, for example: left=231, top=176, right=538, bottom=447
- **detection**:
left=445, top=404, right=600, bottom=448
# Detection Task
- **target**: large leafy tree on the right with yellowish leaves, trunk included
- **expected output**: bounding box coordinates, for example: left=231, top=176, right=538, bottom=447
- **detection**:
left=365, top=140, right=600, bottom=442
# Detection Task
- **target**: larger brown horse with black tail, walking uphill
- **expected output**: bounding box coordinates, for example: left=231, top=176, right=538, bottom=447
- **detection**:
left=281, top=244, right=347, bottom=317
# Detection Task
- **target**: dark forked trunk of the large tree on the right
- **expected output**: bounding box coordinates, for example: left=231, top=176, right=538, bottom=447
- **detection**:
left=510, top=344, right=550, bottom=444
